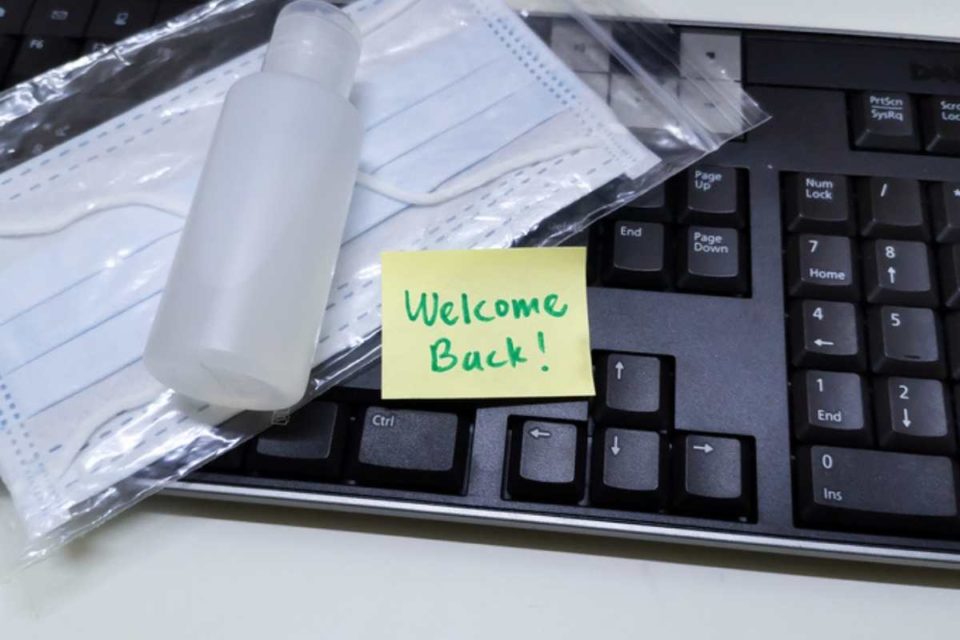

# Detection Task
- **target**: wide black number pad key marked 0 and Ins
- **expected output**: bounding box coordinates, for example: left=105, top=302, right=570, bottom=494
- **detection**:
left=797, top=446, right=958, bottom=535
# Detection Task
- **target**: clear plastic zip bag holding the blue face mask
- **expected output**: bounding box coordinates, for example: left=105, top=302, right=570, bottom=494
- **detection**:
left=0, top=0, right=766, bottom=558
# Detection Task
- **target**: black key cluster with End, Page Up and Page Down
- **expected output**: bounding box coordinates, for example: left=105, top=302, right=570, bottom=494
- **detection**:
left=592, top=165, right=749, bottom=295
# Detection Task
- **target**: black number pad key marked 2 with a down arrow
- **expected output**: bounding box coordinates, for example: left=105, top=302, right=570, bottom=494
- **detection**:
left=874, top=378, right=957, bottom=455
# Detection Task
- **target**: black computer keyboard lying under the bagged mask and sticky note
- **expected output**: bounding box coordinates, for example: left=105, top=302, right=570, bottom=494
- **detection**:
left=0, top=5, right=960, bottom=564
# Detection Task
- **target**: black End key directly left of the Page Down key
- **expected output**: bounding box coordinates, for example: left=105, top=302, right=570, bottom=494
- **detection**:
left=602, top=220, right=671, bottom=288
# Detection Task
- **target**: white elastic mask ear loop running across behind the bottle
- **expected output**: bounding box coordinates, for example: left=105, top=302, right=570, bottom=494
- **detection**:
left=0, top=137, right=600, bottom=238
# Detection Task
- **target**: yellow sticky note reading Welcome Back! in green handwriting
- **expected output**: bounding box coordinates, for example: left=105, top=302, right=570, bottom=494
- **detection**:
left=381, top=247, right=594, bottom=399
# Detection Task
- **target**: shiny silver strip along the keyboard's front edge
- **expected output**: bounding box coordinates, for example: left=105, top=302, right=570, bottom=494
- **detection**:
left=164, top=482, right=960, bottom=569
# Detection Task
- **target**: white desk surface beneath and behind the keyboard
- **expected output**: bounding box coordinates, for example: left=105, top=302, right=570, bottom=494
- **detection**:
left=0, top=0, right=960, bottom=640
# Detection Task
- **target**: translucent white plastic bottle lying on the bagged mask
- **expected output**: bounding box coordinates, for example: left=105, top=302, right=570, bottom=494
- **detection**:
left=144, top=0, right=362, bottom=410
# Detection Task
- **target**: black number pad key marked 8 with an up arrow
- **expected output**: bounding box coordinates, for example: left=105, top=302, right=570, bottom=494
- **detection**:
left=863, top=240, right=937, bottom=307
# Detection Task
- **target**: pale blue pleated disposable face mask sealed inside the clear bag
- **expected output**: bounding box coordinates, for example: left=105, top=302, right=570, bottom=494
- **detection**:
left=0, top=0, right=659, bottom=534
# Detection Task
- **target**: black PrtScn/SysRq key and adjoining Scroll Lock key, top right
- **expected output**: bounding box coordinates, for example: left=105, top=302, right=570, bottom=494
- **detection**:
left=850, top=91, right=960, bottom=156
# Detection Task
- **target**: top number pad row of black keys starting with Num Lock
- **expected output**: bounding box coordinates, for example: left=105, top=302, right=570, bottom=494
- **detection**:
left=783, top=173, right=960, bottom=243
